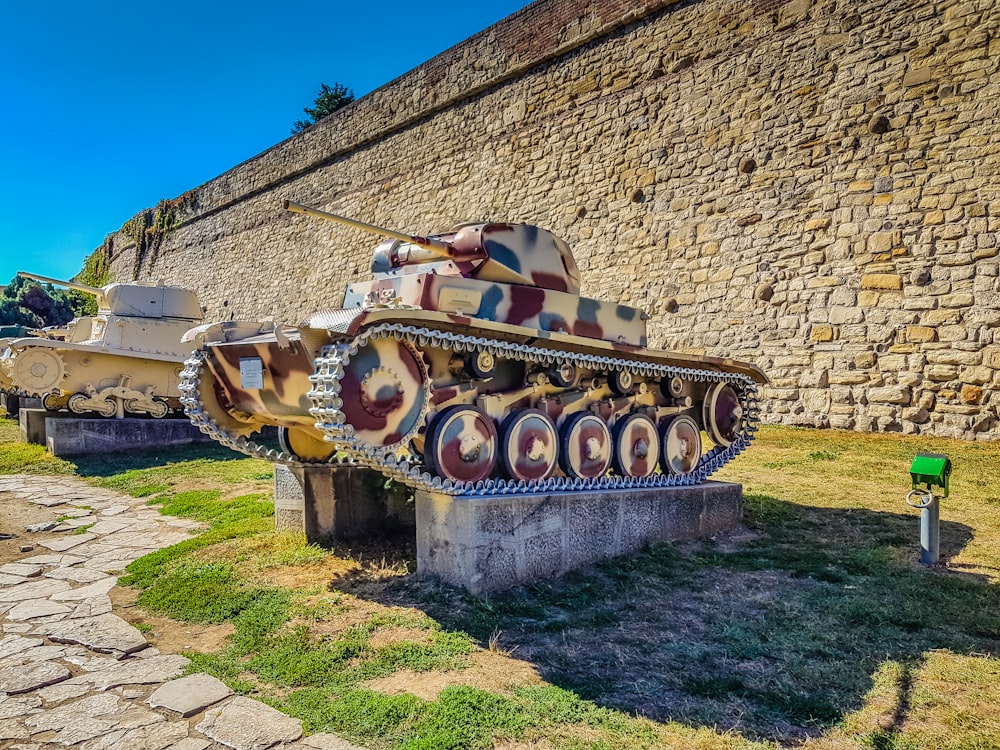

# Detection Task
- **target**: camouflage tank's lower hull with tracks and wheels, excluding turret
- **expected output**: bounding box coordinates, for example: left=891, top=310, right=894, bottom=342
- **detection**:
left=181, top=307, right=766, bottom=494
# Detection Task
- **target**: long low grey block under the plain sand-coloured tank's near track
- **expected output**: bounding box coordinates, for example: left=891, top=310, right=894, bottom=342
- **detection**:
left=45, top=418, right=211, bottom=456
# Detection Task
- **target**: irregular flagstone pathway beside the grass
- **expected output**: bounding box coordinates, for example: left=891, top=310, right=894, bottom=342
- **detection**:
left=0, top=475, right=359, bottom=750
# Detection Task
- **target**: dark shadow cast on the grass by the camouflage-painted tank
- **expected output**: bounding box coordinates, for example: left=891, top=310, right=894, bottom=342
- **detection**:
left=331, top=495, right=1000, bottom=741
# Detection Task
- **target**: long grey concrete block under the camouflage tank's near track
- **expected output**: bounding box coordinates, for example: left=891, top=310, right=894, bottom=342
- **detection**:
left=416, top=482, right=743, bottom=596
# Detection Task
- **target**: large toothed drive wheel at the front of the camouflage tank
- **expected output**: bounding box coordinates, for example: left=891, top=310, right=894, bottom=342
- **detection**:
left=340, top=338, right=430, bottom=448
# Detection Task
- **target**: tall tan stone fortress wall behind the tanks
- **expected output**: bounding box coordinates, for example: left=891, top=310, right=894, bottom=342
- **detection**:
left=107, top=0, right=1000, bottom=440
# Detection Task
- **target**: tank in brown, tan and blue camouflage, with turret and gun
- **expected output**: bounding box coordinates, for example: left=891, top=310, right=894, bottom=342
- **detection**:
left=181, top=201, right=766, bottom=494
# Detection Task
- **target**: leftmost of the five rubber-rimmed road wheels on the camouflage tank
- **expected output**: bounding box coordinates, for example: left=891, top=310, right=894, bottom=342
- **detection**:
left=424, top=405, right=497, bottom=482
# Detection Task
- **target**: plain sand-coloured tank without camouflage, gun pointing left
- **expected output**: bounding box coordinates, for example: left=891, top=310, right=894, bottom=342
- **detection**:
left=0, top=272, right=202, bottom=418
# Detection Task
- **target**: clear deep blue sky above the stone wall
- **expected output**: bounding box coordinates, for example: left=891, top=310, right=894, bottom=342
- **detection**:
left=0, top=0, right=529, bottom=285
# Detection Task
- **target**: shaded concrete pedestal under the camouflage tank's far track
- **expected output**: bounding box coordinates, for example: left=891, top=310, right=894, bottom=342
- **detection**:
left=274, top=465, right=414, bottom=544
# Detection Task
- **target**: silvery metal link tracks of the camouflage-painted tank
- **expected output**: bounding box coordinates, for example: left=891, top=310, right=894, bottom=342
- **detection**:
left=180, top=323, right=760, bottom=495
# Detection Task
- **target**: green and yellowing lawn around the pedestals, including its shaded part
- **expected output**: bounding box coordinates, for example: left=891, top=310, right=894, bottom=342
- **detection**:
left=0, top=422, right=1000, bottom=750
